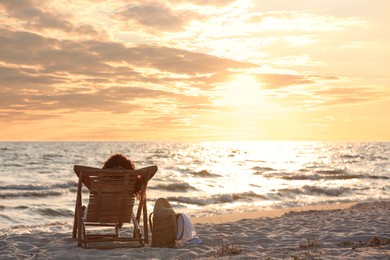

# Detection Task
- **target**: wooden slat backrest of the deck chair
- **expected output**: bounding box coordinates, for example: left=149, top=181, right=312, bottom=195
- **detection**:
left=83, top=169, right=142, bottom=223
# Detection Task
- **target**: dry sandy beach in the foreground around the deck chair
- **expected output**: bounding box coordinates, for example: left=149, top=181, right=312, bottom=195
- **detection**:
left=0, top=201, right=390, bottom=259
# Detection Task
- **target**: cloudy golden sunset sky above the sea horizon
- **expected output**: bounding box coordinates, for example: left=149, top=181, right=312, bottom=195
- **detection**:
left=0, top=0, right=390, bottom=141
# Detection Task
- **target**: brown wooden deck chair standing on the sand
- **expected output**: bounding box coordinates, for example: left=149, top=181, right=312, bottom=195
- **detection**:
left=73, top=165, right=157, bottom=248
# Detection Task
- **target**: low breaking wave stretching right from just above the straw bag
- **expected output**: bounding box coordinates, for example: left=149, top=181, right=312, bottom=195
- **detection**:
left=167, top=192, right=265, bottom=206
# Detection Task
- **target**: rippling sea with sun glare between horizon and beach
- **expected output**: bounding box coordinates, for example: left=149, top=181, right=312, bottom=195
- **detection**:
left=0, top=141, right=390, bottom=230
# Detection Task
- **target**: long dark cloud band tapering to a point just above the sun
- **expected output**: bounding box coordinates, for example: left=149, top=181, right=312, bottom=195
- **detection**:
left=0, top=30, right=256, bottom=75
